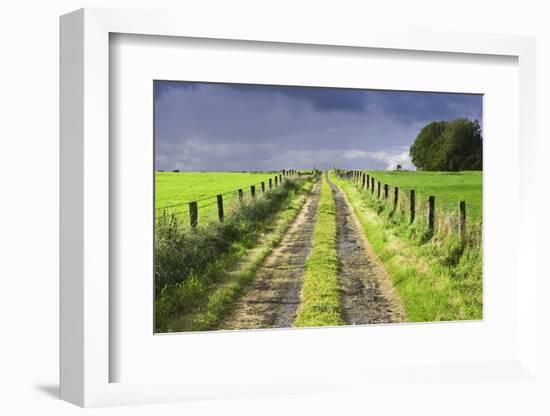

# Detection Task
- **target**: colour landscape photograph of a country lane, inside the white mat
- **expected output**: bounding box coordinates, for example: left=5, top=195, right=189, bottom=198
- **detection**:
left=152, top=80, right=483, bottom=333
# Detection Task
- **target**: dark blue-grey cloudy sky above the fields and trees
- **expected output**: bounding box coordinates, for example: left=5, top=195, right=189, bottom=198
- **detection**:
left=154, top=81, right=482, bottom=171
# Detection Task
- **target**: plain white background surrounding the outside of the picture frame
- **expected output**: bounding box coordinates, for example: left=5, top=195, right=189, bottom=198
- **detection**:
left=0, top=0, right=550, bottom=415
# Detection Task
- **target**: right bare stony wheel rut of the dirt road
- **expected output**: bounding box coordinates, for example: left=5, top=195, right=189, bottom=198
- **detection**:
left=328, top=174, right=404, bottom=325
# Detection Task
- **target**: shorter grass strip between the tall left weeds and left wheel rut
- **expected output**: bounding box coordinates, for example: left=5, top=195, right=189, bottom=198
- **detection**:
left=155, top=178, right=315, bottom=332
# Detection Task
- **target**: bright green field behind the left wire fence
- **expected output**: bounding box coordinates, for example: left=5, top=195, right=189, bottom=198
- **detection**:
left=155, top=172, right=278, bottom=222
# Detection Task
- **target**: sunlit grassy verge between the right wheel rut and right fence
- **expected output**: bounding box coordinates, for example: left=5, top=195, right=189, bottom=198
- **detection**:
left=331, top=173, right=483, bottom=322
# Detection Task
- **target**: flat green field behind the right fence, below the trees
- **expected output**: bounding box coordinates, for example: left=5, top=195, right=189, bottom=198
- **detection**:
left=367, top=171, right=482, bottom=221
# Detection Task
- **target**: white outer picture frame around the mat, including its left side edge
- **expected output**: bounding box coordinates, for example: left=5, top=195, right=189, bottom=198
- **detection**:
left=60, top=9, right=537, bottom=407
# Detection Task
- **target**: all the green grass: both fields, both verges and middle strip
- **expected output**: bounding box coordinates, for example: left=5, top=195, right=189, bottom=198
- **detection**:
left=155, top=167, right=483, bottom=332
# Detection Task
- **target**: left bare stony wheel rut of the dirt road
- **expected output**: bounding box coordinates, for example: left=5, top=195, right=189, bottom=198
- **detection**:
left=219, top=182, right=320, bottom=329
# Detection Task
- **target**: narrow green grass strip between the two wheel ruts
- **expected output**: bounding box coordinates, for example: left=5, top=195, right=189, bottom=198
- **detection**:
left=294, top=173, right=344, bottom=327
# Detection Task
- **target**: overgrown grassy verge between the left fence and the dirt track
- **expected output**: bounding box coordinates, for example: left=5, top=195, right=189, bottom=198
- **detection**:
left=155, top=178, right=320, bottom=332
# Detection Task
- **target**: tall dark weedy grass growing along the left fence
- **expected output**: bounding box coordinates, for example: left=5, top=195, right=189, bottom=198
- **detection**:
left=155, top=177, right=315, bottom=332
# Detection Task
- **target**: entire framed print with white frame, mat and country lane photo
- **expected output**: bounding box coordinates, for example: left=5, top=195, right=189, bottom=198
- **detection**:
left=61, top=9, right=536, bottom=406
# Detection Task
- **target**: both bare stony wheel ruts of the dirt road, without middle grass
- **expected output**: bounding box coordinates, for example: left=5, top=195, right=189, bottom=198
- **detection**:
left=219, top=173, right=405, bottom=329
